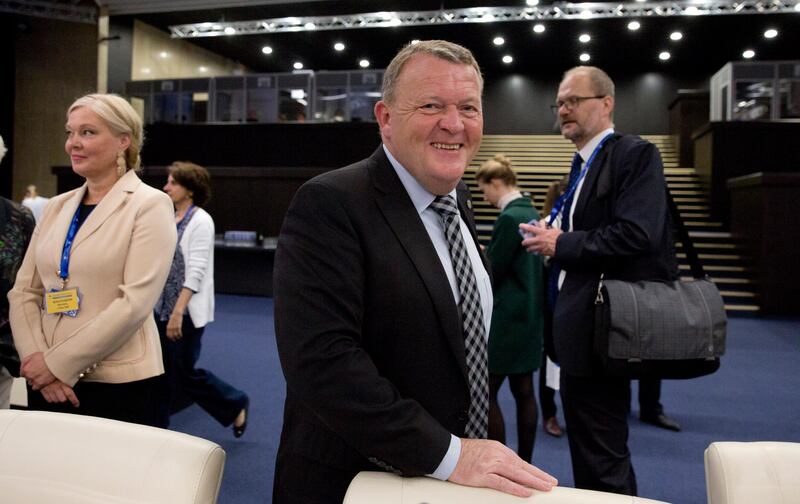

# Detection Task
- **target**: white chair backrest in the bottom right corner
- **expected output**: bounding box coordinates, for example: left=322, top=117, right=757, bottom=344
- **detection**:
left=705, top=441, right=800, bottom=504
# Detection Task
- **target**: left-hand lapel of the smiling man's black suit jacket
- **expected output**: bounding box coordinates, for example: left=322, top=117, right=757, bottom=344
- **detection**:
left=368, top=147, right=467, bottom=380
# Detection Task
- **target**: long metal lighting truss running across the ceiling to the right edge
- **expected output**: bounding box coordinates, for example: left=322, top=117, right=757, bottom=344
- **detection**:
left=170, top=0, right=800, bottom=38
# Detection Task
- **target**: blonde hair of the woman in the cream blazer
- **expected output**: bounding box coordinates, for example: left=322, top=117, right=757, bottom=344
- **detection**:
left=67, top=93, right=144, bottom=171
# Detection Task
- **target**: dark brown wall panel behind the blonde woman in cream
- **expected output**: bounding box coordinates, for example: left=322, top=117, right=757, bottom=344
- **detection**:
left=9, top=18, right=97, bottom=201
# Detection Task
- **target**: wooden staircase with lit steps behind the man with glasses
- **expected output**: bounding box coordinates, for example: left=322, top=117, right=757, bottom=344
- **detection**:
left=464, top=135, right=759, bottom=315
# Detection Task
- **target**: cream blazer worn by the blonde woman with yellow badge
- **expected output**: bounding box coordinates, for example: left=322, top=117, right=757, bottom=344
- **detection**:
left=8, top=171, right=177, bottom=386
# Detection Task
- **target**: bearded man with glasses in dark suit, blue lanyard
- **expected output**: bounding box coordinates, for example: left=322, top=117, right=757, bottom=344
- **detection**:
left=520, top=66, right=678, bottom=495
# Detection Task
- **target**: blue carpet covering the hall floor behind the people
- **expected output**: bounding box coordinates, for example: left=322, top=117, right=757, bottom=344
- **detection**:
left=171, top=296, right=800, bottom=504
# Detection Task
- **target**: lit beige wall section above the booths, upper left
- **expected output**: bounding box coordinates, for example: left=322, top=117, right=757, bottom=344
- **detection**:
left=131, top=20, right=246, bottom=80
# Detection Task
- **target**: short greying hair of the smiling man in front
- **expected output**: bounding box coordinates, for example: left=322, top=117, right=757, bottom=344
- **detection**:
left=383, top=40, right=483, bottom=104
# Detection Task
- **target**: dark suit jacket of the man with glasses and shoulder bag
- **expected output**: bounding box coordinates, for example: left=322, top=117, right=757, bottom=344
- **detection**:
left=553, top=134, right=678, bottom=376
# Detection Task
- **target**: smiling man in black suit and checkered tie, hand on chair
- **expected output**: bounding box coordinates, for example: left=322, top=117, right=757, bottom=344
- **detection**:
left=273, top=41, right=556, bottom=504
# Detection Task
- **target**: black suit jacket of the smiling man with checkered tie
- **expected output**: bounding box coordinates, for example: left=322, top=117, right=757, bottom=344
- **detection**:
left=274, top=147, right=488, bottom=502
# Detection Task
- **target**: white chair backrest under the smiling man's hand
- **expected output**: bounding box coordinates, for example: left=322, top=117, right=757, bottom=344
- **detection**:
left=343, top=472, right=665, bottom=504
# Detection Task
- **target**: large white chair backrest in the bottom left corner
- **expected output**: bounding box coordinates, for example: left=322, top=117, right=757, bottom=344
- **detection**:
left=0, top=410, right=225, bottom=504
